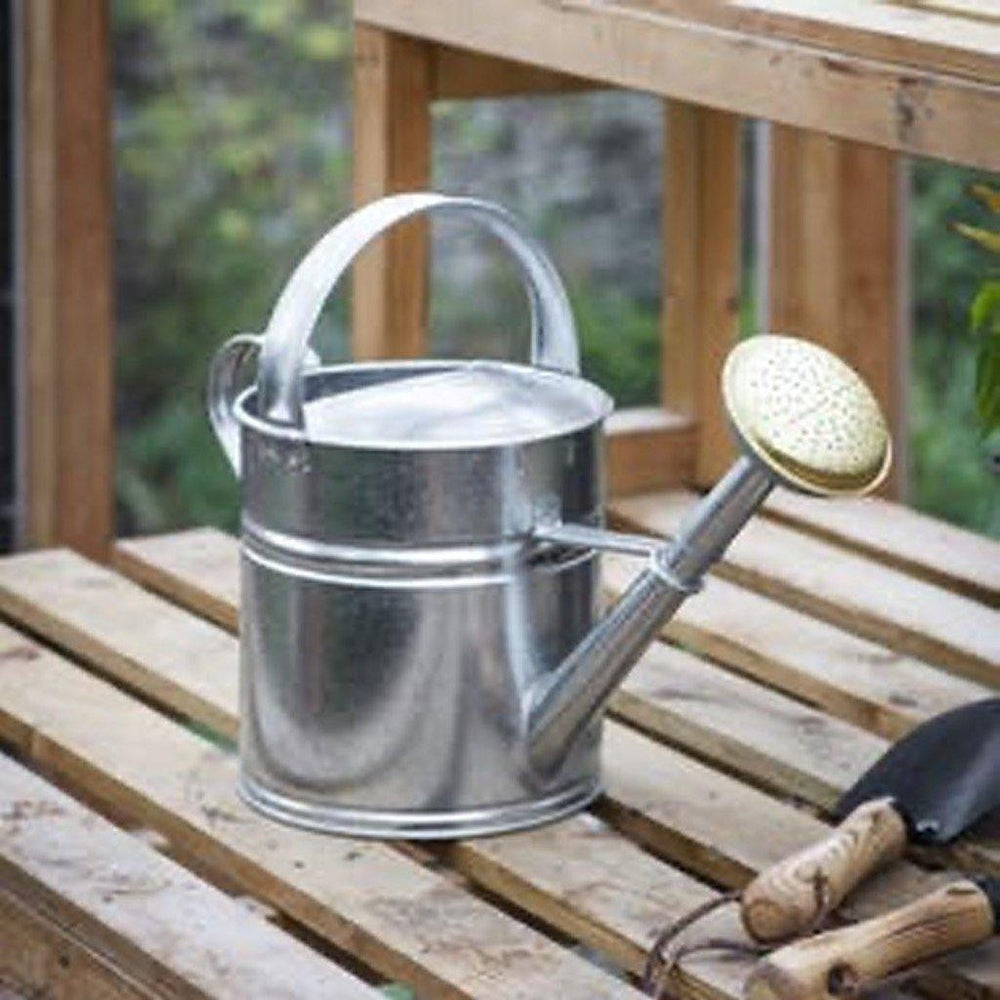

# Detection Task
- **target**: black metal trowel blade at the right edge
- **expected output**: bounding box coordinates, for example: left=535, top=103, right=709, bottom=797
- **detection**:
left=837, top=698, right=1000, bottom=844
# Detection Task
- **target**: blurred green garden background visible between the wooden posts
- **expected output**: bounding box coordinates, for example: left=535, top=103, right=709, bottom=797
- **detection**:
left=112, top=0, right=1000, bottom=537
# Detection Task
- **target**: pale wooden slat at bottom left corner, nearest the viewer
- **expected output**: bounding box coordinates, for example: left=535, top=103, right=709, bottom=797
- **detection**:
left=0, top=756, right=378, bottom=1000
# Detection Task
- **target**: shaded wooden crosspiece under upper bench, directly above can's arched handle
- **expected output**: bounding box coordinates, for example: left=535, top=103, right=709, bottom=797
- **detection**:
left=431, top=45, right=595, bottom=100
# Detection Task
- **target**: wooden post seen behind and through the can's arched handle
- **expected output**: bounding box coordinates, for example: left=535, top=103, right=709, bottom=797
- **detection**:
left=351, top=24, right=432, bottom=360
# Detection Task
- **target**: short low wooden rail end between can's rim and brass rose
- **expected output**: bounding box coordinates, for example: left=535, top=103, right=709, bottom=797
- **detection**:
left=606, top=407, right=696, bottom=496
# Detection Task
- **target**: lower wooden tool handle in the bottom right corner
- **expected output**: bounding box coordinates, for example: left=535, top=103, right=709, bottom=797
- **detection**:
left=744, top=880, right=996, bottom=1000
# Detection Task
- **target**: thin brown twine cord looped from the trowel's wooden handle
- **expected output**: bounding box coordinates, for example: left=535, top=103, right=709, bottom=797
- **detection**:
left=642, top=871, right=831, bottom=1000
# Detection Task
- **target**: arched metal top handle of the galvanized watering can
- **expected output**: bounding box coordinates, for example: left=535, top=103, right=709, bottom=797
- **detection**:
left=257, top=193, right=580, bottom=429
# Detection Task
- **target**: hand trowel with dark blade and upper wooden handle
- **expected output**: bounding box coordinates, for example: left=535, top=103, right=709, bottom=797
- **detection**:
left=741, top=698, right=1000, bottom=943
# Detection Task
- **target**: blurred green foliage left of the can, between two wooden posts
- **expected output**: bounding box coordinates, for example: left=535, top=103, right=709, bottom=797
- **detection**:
left=114, top=0, right=349, bottom=533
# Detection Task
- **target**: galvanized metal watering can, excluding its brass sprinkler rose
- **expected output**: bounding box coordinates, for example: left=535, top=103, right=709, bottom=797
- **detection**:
left=209, top=194, right=888, bottom=838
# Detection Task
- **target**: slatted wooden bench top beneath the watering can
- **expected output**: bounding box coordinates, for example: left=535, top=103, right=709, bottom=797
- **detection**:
left=0, top=492, right=1000, bottom=1000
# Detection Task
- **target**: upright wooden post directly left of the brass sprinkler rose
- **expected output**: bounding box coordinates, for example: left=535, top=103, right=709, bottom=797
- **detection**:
left=661, top=101, right=741, bottom=486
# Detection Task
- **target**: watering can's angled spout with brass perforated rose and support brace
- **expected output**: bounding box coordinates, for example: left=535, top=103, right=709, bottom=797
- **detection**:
left=523, top=336, right=891, bottom=774
